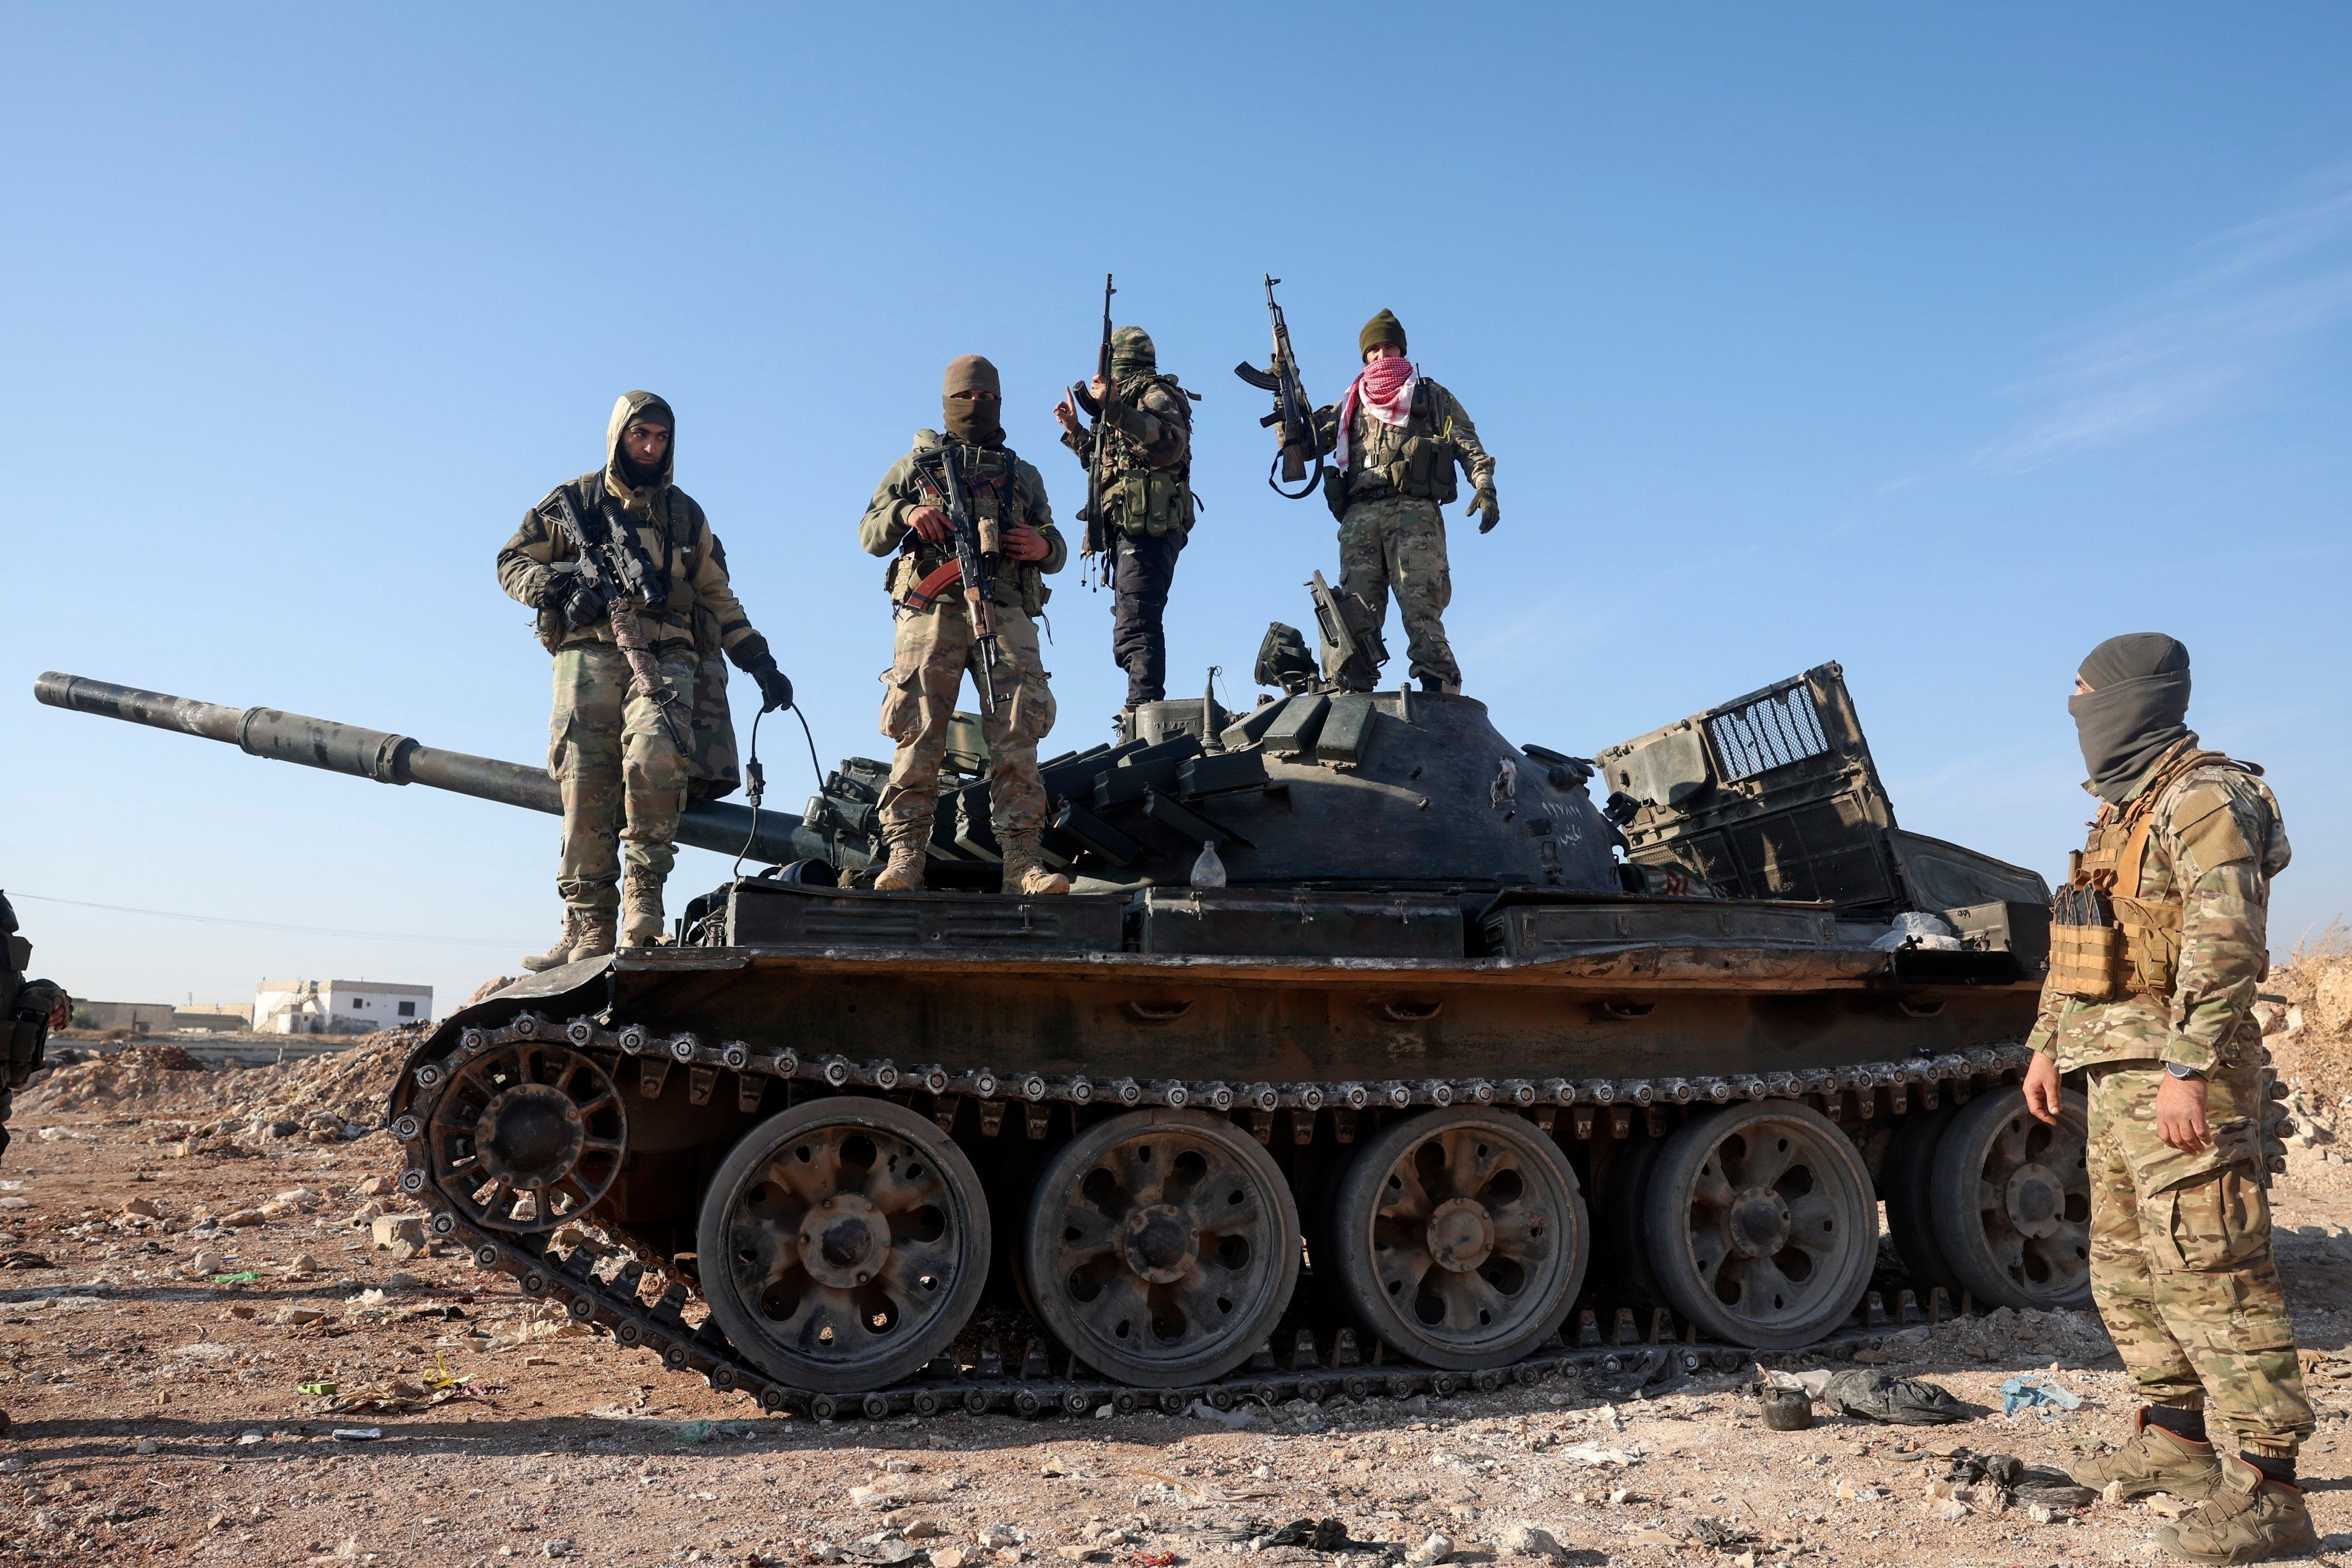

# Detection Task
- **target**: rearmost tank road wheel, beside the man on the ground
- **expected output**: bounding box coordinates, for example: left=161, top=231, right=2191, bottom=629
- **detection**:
left=1928, top=1086, right=2091, bottom=1310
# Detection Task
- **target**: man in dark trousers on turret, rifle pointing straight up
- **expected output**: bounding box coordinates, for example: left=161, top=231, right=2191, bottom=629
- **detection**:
left=1054, top=327, right=1192, bottom=712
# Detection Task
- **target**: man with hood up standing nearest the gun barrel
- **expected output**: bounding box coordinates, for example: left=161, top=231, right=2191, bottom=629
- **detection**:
left=499, top=393, right=793, bottom=971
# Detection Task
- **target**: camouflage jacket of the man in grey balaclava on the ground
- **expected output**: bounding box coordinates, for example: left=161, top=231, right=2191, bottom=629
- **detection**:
left=2027, top=736, right=2291, bottom=1072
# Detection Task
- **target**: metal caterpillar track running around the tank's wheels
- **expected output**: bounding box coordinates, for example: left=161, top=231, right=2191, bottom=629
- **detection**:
left=391, top=1013, right=2032, bottom=1420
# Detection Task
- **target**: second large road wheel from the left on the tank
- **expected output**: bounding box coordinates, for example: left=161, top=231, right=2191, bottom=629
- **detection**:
left=1021, top=1110, right=1298, bottom=1389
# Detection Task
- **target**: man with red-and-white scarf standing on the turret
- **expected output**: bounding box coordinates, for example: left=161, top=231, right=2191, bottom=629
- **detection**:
left=1315, top=310, right=1503, bottom=691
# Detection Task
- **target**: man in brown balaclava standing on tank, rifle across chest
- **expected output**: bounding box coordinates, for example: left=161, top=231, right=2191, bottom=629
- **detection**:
left=859, top=355, right=1070, bottom=893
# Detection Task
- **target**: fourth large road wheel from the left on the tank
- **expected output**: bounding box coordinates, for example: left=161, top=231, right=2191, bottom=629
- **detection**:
left=1649, top=1100, right=1879, bottom=1349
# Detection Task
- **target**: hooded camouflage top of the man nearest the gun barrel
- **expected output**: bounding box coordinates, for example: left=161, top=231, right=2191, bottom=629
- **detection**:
left=499, top=393, right=752, bottom=651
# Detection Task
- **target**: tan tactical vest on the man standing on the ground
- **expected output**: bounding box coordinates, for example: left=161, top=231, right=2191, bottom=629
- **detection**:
left=2051, top=750, right=2251, bottom=1002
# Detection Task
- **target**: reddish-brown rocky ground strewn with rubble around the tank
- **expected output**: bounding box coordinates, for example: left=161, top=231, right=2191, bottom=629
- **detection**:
left=14, top=949, right=2352, bottom=1568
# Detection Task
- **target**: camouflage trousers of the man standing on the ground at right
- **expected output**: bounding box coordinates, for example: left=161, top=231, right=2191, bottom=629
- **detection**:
left=2086, top=1063, right=2312, bottom=1455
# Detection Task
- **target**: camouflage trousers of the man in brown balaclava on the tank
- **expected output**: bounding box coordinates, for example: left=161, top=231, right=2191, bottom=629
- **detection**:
left=875, top=602, right=1054, bottom=844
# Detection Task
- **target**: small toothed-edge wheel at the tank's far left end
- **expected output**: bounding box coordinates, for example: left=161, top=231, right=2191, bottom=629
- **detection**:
left=426, top=1039, right=628, bottom=1232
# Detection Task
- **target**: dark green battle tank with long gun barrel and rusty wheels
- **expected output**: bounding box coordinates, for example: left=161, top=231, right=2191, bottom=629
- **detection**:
left=38, top=625, right=2164, bottom=1418
